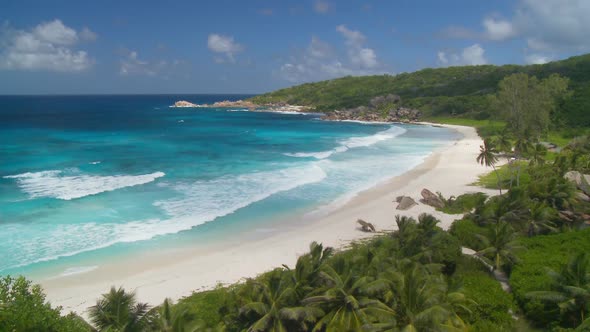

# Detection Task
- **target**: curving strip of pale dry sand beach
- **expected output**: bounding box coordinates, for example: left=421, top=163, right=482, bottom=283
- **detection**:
left=39, top=125, right=495, bottom=315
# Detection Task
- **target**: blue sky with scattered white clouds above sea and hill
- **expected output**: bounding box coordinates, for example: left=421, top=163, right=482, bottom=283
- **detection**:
left=0, top=0, right=590, bottom=94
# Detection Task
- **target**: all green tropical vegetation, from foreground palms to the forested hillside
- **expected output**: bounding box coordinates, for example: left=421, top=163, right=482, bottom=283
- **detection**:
left=0, top=56, right=590, bottom=332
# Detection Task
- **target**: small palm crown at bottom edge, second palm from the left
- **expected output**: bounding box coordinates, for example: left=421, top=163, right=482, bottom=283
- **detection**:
left=150, top=299, right=202, bottom=332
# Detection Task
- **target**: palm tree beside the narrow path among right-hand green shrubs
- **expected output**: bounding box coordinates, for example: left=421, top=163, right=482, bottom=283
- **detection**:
left=476, top=222, right=523, bottom=271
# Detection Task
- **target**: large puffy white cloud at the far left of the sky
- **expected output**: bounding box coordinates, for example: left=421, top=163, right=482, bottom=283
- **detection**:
left=0, top=19, right=94, bottom=72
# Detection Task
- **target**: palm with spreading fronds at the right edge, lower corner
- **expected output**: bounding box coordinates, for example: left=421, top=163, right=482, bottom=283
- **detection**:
left=527, top=252, right=590, bottom=326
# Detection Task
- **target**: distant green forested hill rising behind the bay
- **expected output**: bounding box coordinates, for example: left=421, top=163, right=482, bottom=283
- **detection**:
left=251, top=54, right=590, bottom=126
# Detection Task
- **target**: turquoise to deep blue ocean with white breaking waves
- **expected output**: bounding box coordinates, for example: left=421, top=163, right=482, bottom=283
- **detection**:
left=0, top=95, right=458, bottom=274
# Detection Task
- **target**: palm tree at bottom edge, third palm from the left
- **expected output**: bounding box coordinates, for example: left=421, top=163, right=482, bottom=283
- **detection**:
left=239, top=269, right=323, bottom=332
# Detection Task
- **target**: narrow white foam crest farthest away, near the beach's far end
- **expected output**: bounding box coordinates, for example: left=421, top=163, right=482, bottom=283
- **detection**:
left=284, top=126, right=406, bottom=159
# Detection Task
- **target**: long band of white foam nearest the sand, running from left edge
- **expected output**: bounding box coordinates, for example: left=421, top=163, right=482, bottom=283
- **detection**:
left=0, top=164, right=326, bottom=273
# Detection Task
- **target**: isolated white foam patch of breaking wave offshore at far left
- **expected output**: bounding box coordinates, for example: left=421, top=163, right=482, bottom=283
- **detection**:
left=4, top=170, right=165, bottom=200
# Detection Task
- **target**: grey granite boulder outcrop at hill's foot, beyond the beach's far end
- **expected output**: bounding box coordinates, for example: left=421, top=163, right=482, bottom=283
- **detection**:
left=322, top=94, right=421, bottom=122
